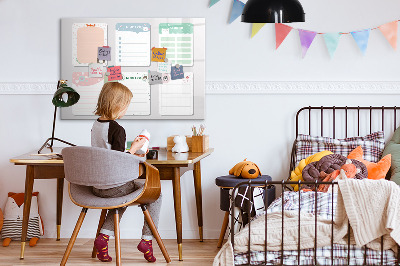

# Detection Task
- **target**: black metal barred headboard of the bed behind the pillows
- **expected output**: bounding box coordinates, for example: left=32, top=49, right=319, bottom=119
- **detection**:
left=289, top=106, right=400, bottom=180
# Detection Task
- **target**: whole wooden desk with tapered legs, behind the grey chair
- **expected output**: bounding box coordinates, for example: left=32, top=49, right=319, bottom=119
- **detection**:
left=10, top=148, right=214, bottom=260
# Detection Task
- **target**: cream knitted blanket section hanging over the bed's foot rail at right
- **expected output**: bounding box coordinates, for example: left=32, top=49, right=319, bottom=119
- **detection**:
left=335, top=179, right=400, bottom=251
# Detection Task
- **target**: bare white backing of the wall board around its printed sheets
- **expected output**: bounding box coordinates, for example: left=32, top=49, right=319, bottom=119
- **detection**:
left=60, top=18, right=205, bottom=120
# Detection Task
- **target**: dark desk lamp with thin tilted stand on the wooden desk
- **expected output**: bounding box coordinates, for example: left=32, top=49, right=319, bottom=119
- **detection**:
left=38, top=80, right=80, bottom=153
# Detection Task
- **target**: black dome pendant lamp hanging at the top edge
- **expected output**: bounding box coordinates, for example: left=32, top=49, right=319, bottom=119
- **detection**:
left=242, top=0, right=304, bottom=23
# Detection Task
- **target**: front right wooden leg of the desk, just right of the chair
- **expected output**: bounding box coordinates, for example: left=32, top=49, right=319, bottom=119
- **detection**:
left=172, top=167, right=182, bottom=261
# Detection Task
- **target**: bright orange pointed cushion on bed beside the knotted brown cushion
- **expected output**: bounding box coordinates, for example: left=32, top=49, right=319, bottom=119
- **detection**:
left=347, top=146, right=392, bottom=180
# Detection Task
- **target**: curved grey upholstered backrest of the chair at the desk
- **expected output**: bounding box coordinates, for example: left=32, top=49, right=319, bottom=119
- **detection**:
left=62, top=146, right=144, bottom=187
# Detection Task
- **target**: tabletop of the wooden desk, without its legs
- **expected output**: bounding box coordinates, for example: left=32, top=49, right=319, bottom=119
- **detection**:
left=10, top=147, right=214, bottom=165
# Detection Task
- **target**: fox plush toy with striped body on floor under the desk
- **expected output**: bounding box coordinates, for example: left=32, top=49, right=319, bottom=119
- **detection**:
left=1, top=192, right=43, bottom=247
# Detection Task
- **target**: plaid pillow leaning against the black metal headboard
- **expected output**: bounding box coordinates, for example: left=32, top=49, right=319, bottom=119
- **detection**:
left=295, top=131, right=385, bottom=165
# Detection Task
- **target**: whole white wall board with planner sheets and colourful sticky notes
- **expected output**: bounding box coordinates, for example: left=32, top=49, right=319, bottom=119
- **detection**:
left=60, top=18, right=205, bottom=119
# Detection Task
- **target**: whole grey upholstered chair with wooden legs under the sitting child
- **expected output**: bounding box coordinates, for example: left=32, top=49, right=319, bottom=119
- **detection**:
left=60, top=146, right=171, bottom=265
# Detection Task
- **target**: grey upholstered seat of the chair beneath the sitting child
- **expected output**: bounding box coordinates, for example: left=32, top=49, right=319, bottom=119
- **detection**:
left=70, top=180, right=144, bottom=208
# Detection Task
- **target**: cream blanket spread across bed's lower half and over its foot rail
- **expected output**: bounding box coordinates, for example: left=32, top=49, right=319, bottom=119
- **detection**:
left=213, top=179, right=400, bottom=266
